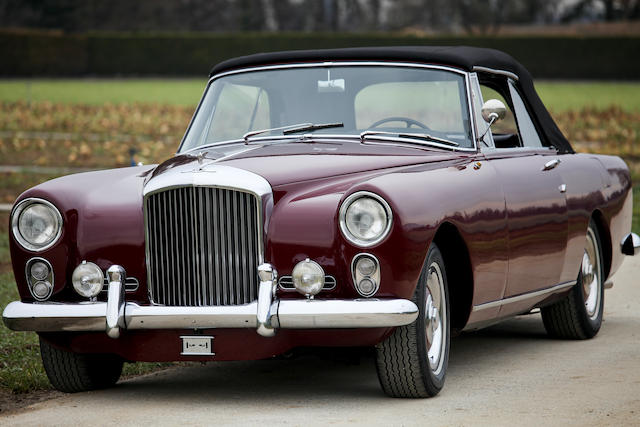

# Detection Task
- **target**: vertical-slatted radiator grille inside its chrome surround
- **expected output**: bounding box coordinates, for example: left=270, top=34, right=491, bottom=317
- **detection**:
left=145, top=187, right=261, bottom=306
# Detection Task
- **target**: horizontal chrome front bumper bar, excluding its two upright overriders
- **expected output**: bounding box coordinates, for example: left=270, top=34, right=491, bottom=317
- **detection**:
left=2, top=299, right=418, bottom=332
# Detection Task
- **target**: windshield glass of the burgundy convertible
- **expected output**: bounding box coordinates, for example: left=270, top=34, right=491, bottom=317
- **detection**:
left=180, top=64, right=473, bottom=151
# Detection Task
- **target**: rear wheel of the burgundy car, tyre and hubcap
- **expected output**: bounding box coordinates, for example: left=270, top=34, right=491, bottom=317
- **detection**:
left=541, top=220, right=604, bottom=340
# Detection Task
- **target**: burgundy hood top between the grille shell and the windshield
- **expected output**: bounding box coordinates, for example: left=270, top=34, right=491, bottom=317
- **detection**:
left=152, top=140, right=468, bottom=187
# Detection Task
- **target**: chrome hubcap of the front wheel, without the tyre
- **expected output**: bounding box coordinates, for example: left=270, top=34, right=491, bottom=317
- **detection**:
left=424, top=262, right=447, bottom=375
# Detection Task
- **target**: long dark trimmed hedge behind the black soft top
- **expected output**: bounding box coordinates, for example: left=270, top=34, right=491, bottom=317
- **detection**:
left=0, top=31, right=640, bottom=80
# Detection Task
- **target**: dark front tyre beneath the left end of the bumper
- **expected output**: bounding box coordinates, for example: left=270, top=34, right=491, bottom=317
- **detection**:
left=40, top=338, right=123, bottom=393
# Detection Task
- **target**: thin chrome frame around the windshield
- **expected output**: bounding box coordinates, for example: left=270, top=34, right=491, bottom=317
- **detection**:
left=176, top=61, right=478, bottom=155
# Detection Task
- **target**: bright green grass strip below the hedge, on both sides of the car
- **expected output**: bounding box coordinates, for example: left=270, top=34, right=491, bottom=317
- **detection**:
left=0, top=77, right=640, bottom=112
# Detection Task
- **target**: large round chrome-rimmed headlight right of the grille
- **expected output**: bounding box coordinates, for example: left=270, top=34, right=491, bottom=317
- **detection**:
left=340, top=191, right=392, bottom=248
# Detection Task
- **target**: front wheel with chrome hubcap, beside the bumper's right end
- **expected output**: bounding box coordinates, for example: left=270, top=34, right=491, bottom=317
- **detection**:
left=376, top=243, right=451, bottom=397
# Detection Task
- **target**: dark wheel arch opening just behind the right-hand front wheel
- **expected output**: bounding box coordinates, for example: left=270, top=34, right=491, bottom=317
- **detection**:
left=433, top=222, right=473, bottom=333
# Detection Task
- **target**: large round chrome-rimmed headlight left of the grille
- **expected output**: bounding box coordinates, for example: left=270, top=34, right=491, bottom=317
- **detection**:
left=11, top=199, right=62, bottom=252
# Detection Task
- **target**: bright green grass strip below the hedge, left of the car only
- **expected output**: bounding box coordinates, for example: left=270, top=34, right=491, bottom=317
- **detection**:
left=0, top=78, right=206, bottom=105
